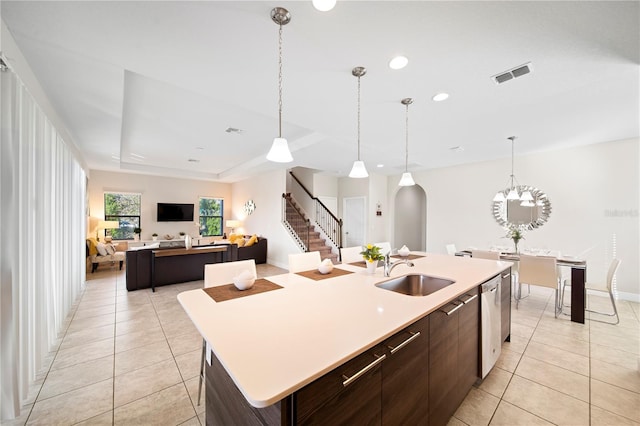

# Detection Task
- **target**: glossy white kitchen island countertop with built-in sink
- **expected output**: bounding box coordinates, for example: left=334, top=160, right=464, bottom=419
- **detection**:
left=178, top=252, right=511, bottom=408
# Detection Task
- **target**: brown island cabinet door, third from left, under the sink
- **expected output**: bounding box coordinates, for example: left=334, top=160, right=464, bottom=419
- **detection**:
left=429, top=302, right=461, bottom=426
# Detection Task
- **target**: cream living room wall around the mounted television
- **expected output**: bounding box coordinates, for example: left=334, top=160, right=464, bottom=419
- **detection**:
left=88, top=170, right=232, bottom=240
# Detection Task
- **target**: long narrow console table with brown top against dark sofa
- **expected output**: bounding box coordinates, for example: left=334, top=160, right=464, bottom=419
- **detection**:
left=151, top=245, right=227, bottom=292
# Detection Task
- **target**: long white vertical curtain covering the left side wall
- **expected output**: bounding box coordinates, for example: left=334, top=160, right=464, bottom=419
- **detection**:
left=0, top=62, right=86, bottom=420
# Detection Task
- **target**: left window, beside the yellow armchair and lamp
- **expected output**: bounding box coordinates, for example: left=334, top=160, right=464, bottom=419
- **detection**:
left=104, top=192, right=142, bottom=240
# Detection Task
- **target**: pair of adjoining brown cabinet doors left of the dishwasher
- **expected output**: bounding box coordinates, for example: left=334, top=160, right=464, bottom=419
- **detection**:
left=429, top=289, right=480, bottom=426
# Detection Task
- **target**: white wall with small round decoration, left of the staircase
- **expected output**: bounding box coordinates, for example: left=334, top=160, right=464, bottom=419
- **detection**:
left=231, top=170, right=300, bottom=268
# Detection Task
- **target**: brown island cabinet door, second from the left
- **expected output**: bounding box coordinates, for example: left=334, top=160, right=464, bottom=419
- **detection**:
left=382, top=317, right=429, bottom=425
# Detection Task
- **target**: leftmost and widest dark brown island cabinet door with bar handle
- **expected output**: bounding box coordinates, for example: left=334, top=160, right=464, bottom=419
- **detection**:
left=295, top=347, right=386, bottom=425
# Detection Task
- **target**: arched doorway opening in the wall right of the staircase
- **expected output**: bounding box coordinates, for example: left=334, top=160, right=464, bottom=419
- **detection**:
left=393, top=185, right=427, bottom=251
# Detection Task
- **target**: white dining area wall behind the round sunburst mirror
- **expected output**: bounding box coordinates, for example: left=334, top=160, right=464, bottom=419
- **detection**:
left=402, top=139, right=640, bottom=299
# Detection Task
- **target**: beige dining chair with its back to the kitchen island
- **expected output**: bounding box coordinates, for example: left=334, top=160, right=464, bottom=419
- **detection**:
left=516, top=254, right=561, bottom=318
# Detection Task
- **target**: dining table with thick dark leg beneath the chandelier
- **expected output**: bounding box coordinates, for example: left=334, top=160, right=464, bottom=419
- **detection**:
left=456, top=249, right=587, bottom=324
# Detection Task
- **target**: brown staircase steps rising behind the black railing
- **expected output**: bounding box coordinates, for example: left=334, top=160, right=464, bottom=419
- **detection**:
left=283, top=194, right=338, bottom=263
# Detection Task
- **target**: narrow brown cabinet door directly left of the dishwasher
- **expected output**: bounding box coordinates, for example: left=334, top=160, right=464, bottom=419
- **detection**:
left=456, top=288, right=480, bottom=405
